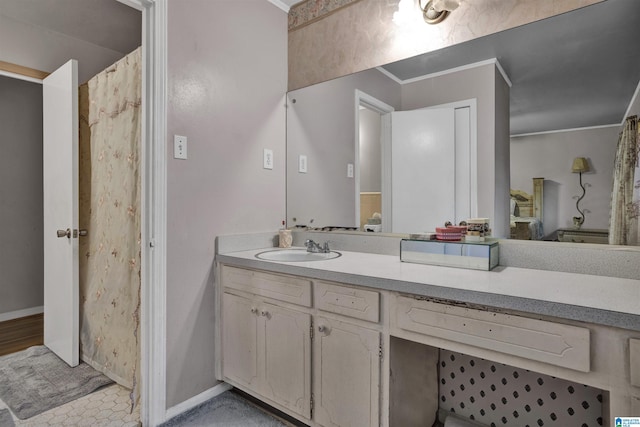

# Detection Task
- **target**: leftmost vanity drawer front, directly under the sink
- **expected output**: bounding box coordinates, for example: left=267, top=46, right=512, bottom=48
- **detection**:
left=222, top=266, right=311, bottom=307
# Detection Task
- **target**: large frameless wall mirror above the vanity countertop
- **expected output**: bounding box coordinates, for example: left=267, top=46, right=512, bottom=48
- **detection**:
left=287, top=0, right=640, bottom=246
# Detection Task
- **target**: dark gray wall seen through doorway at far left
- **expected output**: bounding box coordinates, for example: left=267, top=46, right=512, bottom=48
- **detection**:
left=0, top=76, right=44, bottom=314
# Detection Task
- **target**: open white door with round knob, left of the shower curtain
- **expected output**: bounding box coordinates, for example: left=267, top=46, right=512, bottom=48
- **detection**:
left=42, top=60, right=80, bottom=366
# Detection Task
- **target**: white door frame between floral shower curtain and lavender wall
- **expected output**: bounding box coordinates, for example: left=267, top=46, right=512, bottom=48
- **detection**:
left=125, top=0, right=168, bottom=426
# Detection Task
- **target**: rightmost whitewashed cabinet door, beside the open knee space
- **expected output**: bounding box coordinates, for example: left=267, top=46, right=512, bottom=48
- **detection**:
left=313, top=317, right=380, bottom=427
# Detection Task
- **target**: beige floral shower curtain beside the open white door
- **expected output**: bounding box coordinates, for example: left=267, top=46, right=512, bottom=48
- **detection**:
left=79, top=48, right=142, bottom=406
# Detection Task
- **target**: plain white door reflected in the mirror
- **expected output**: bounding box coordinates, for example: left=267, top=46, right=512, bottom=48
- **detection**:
left=391, top=108, right=456, bottom=233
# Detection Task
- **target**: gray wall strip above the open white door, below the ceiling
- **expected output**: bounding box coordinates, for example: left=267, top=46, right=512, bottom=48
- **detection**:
left=0, top=14, right=129, bottom=83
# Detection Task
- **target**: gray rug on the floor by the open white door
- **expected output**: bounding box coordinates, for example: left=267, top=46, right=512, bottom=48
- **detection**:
left=0, top=346, right=113, bottom=420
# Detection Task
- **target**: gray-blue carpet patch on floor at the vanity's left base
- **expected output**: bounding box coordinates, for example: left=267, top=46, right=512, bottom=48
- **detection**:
left=162, top=391, right=285, bottom=427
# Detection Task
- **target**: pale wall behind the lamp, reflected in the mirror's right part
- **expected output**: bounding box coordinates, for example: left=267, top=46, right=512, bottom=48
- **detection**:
left=511, top=126, right=620, bottom=234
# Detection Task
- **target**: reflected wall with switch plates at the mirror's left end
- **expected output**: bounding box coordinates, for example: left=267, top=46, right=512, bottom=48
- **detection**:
left=287, top=69, right=400, bottom=227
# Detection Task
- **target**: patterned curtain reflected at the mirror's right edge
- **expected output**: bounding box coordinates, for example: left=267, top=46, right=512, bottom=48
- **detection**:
left=609, top=116, right=640, bottom=245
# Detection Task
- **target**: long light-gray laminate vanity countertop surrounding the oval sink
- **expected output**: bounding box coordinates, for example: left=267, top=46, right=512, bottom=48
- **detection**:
left=216, top=248, right=640, bottom=331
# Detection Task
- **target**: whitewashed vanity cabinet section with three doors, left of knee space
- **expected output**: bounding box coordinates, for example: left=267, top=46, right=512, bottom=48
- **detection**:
left=221, top=265, right=382, bottom=427
